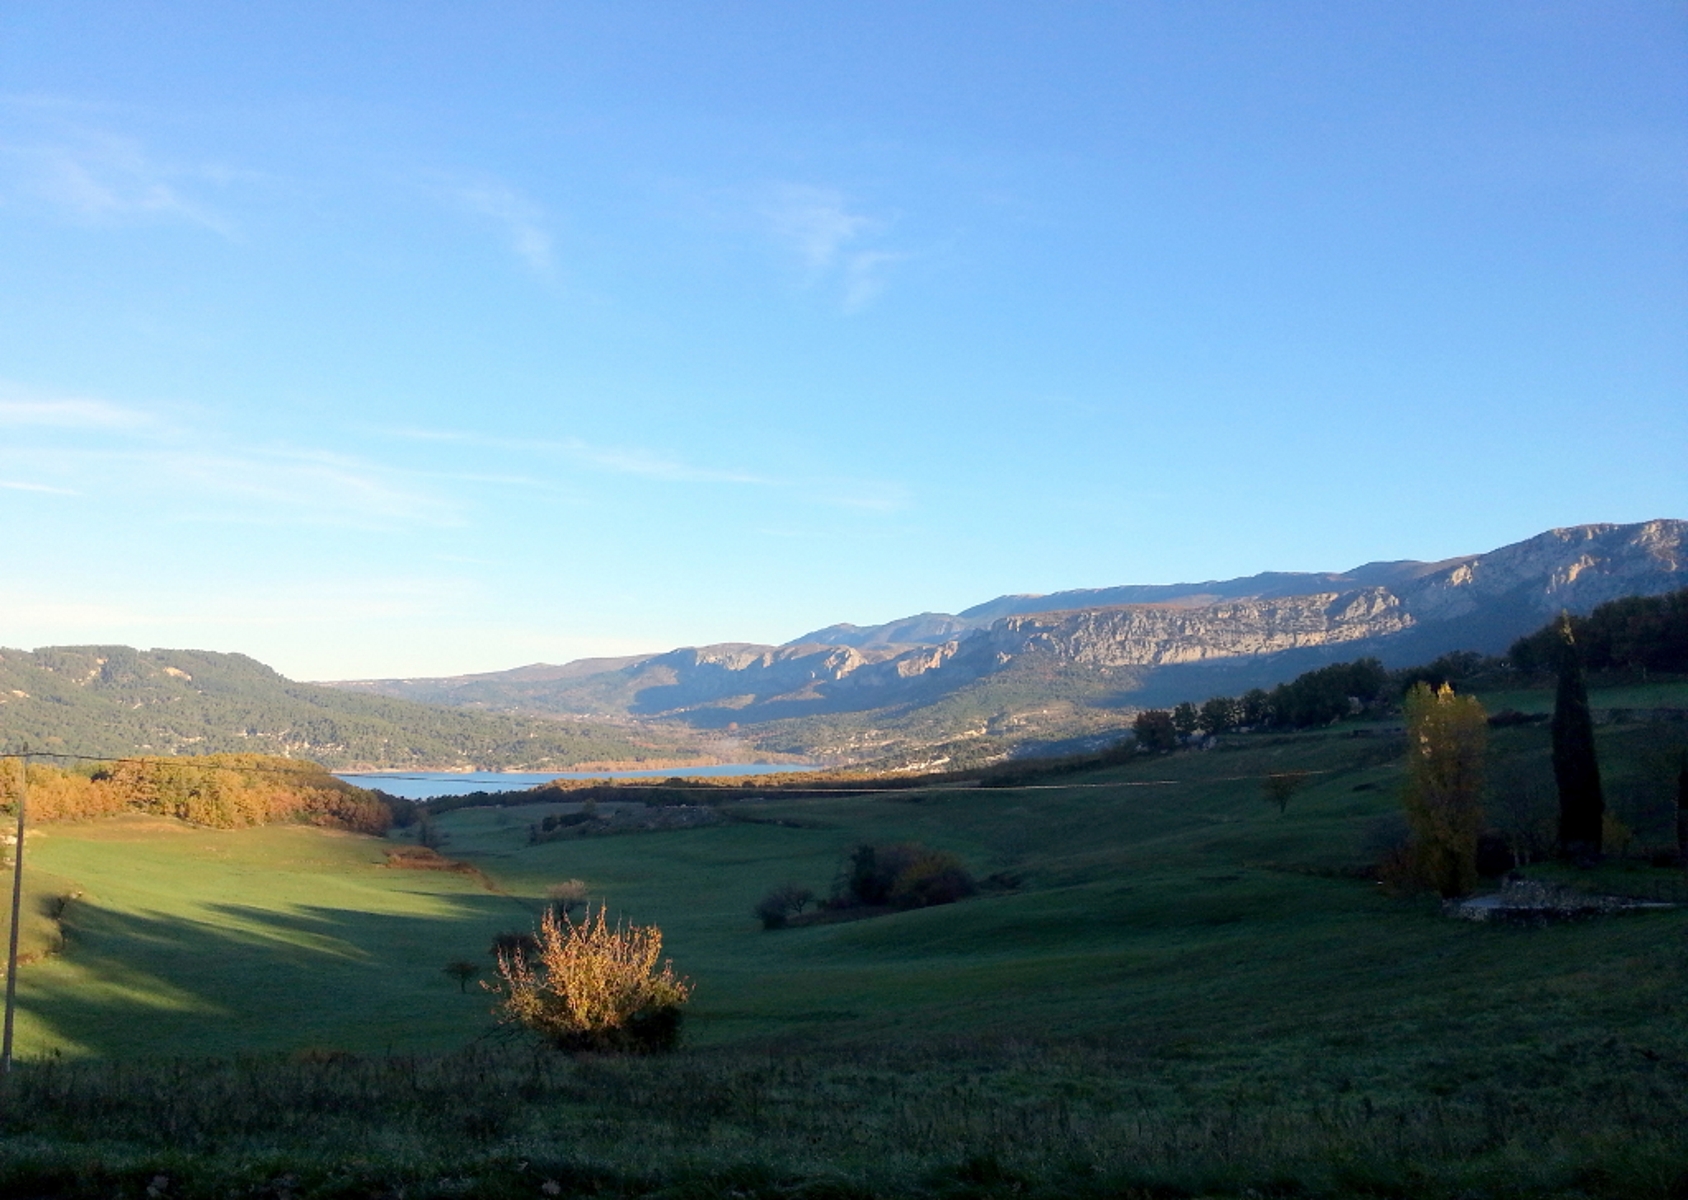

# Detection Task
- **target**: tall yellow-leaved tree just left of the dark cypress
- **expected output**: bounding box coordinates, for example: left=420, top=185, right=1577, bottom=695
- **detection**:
left=1404, top=684, right=1489, bottom=898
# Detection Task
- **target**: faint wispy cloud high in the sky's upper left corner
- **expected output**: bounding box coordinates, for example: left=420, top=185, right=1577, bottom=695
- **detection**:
left=0, top=130, right=235, bottom=238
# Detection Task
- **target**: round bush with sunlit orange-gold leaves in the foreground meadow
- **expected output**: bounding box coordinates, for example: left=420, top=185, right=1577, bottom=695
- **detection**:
left=488, top=908, right=692, bottom=1051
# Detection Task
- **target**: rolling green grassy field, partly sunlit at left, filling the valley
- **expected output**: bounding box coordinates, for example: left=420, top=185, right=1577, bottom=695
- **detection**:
left=0, top=695, right=1688, bottom=1197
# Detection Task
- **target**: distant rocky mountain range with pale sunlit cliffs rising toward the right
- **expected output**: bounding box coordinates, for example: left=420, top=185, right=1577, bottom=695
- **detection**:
left=331, top=520, right=1688, bottom=761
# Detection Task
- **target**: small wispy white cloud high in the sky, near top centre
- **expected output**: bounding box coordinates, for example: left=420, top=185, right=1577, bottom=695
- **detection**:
left=761, top=184, right=908, bottom=312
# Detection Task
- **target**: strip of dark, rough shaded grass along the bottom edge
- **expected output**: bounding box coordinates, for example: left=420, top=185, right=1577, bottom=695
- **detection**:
left=0, top=1040, right=1688, bottom=1197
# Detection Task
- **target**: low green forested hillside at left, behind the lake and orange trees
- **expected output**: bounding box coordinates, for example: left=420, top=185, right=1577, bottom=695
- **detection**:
left=0, top=646, right=706, bottom=770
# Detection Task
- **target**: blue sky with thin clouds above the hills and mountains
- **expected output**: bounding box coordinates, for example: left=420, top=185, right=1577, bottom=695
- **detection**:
left=0, top=0, right=1688, bottom=678
